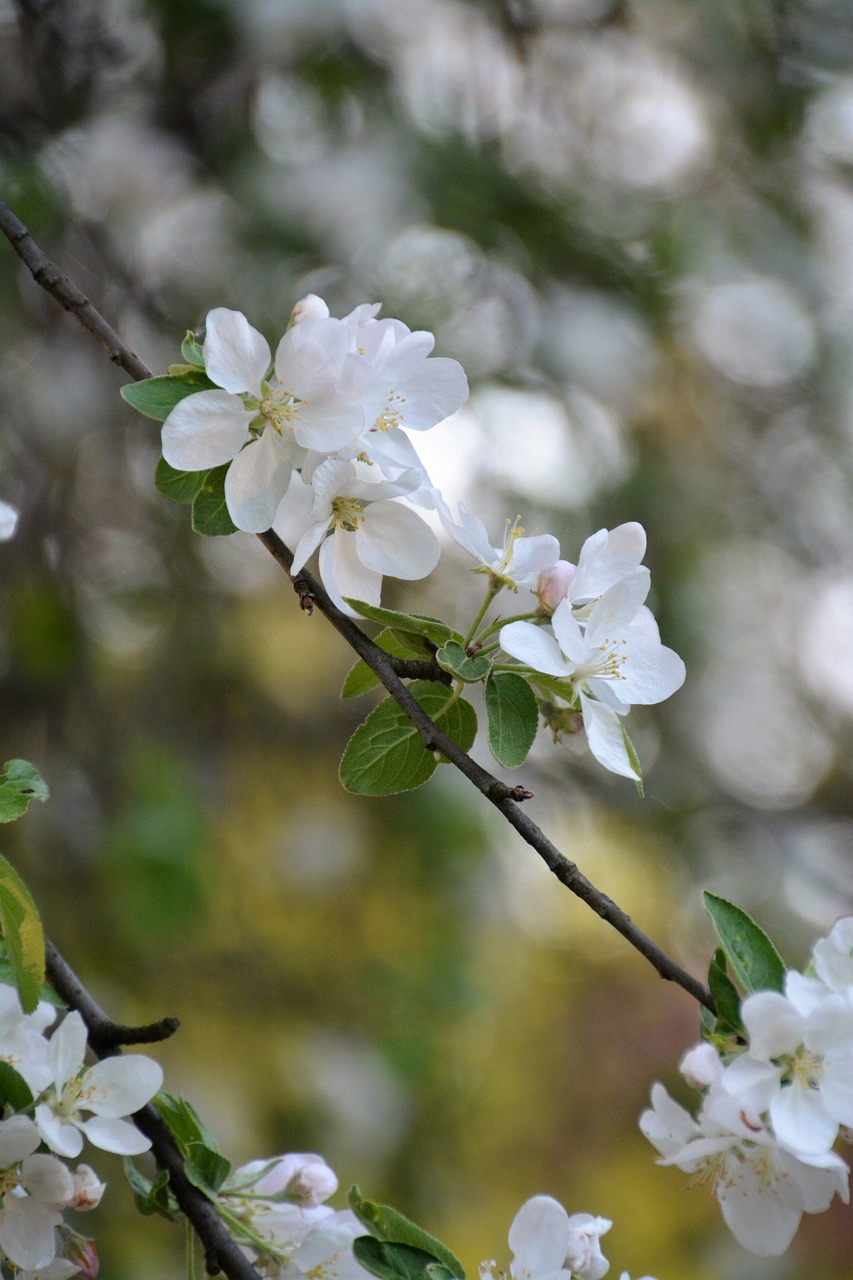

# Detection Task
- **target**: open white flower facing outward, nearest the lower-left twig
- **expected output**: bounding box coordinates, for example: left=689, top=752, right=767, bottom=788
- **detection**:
left=36, top=1012, right=163, bottom=1157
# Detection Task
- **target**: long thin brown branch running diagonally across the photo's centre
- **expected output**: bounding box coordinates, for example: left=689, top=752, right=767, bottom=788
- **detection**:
left=0, top=202, right=715, bottom=1012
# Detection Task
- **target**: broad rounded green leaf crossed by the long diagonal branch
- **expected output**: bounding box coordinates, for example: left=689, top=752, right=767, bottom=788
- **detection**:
left=341, top=680, right=476, bottom=796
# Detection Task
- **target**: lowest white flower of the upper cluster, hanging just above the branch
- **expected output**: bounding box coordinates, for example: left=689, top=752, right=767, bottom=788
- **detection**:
left=274, top=458, right=441, bottom=616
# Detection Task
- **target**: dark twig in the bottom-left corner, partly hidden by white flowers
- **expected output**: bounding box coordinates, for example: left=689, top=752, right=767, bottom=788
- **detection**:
left=45, top=942, right=260, bottom=1280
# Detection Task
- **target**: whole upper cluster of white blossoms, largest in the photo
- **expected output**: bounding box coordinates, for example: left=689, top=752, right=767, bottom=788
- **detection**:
left=163, top=302, right=467, bottom=613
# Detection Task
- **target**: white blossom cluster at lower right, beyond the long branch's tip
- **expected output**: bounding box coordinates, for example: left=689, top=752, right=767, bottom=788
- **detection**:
left=640, top=916, right=853, bottom=1257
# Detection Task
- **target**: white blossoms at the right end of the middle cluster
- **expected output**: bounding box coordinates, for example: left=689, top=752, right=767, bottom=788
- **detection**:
left=501, top=524, right=684, bottom=781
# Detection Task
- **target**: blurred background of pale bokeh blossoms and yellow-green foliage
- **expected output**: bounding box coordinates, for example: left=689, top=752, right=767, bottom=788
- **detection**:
left=0, top=0, right=853, bottom=1280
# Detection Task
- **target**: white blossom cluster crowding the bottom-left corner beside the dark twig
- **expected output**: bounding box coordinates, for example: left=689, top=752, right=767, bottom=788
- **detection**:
left=0, top=984, right=163, bottom=1280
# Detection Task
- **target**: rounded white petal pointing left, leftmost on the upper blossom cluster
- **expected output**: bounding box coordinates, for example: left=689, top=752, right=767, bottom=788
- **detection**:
left=161, top=392, right=252, bottom=471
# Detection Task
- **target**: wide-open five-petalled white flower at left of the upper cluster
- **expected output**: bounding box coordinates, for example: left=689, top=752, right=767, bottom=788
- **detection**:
left=163, top=303, right=364, bottom=532
